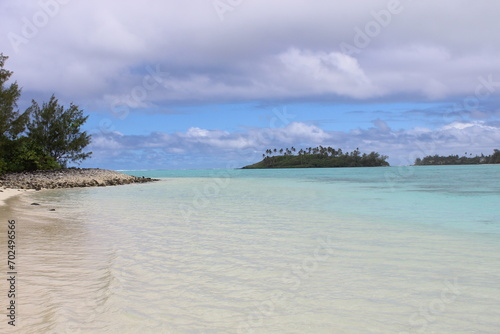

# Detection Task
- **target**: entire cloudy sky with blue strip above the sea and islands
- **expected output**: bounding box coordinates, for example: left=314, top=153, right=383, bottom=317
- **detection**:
left=0, top=0, right=500, bottom=170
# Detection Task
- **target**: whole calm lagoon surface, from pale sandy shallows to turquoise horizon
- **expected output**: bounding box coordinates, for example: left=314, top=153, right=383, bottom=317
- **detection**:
left=0, top=166, right=500, bottom=334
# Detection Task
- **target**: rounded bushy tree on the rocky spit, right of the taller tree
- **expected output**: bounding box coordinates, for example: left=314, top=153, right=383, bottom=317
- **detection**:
left=28, top=95, right=92, bottom=167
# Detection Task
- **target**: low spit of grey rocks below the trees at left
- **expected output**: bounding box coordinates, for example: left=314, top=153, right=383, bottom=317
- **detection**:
left=0, top=168, right=158, bottom=190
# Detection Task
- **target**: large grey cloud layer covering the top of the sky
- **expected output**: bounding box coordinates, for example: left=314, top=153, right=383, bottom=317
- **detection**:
left=0, top=0, right=500, bottom=105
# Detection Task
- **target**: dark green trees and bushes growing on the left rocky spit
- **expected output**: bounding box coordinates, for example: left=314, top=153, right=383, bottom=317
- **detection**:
left=0, top=53, right=92, bottom=174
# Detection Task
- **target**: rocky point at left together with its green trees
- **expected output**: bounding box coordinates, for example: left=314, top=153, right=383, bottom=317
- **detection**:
left=0, top=53, right=156, bottom=191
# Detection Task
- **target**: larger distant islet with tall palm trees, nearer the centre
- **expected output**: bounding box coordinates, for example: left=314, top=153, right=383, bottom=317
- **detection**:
left=243, top=146, right=389, bottom=169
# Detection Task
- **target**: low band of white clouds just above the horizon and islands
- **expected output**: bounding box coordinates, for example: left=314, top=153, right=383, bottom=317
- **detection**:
left=85, top=120, right=500, bottom=168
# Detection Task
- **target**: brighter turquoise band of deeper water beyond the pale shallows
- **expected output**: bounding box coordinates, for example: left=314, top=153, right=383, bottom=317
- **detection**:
left=125, top=165, right=500, bottom=234
